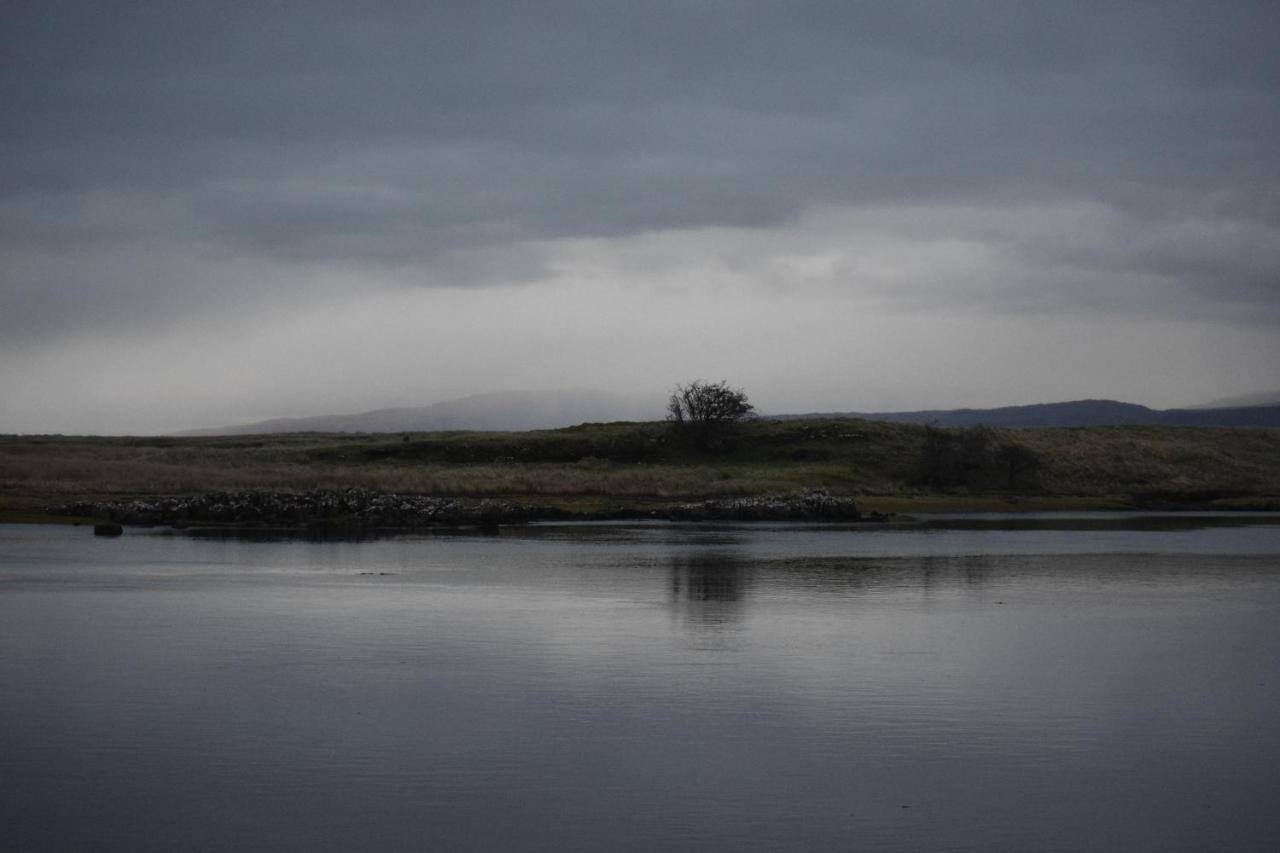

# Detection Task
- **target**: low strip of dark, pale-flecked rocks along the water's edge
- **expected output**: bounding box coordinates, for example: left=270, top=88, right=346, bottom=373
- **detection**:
left=47, top=488, right=884, bottom=529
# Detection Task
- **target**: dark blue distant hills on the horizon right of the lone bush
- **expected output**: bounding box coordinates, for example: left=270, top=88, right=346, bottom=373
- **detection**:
left=785, top=400, right=1280, bottom=428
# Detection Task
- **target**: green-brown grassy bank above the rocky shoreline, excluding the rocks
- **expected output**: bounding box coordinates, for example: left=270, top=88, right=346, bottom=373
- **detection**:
left=0, top=420, right=1280, bottom=520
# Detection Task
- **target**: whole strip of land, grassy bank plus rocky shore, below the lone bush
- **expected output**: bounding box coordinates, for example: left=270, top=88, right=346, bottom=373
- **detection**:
left=0, top=418, right=1280, bottom=528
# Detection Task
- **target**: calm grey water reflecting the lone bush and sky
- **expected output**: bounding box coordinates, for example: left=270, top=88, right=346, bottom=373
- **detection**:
left=0, top=515, right=1280, bottom=852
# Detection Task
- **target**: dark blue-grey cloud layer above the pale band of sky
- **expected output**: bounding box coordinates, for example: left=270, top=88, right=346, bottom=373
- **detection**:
left=0, top=0, right=1280, bottom=358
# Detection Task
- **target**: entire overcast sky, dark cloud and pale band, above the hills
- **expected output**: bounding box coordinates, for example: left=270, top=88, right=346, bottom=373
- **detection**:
left=0, top=0, right=1280, bottom=433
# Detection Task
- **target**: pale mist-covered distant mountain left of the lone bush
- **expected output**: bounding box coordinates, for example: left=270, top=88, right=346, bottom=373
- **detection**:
left=182, top=389, right=666, bottom=435
